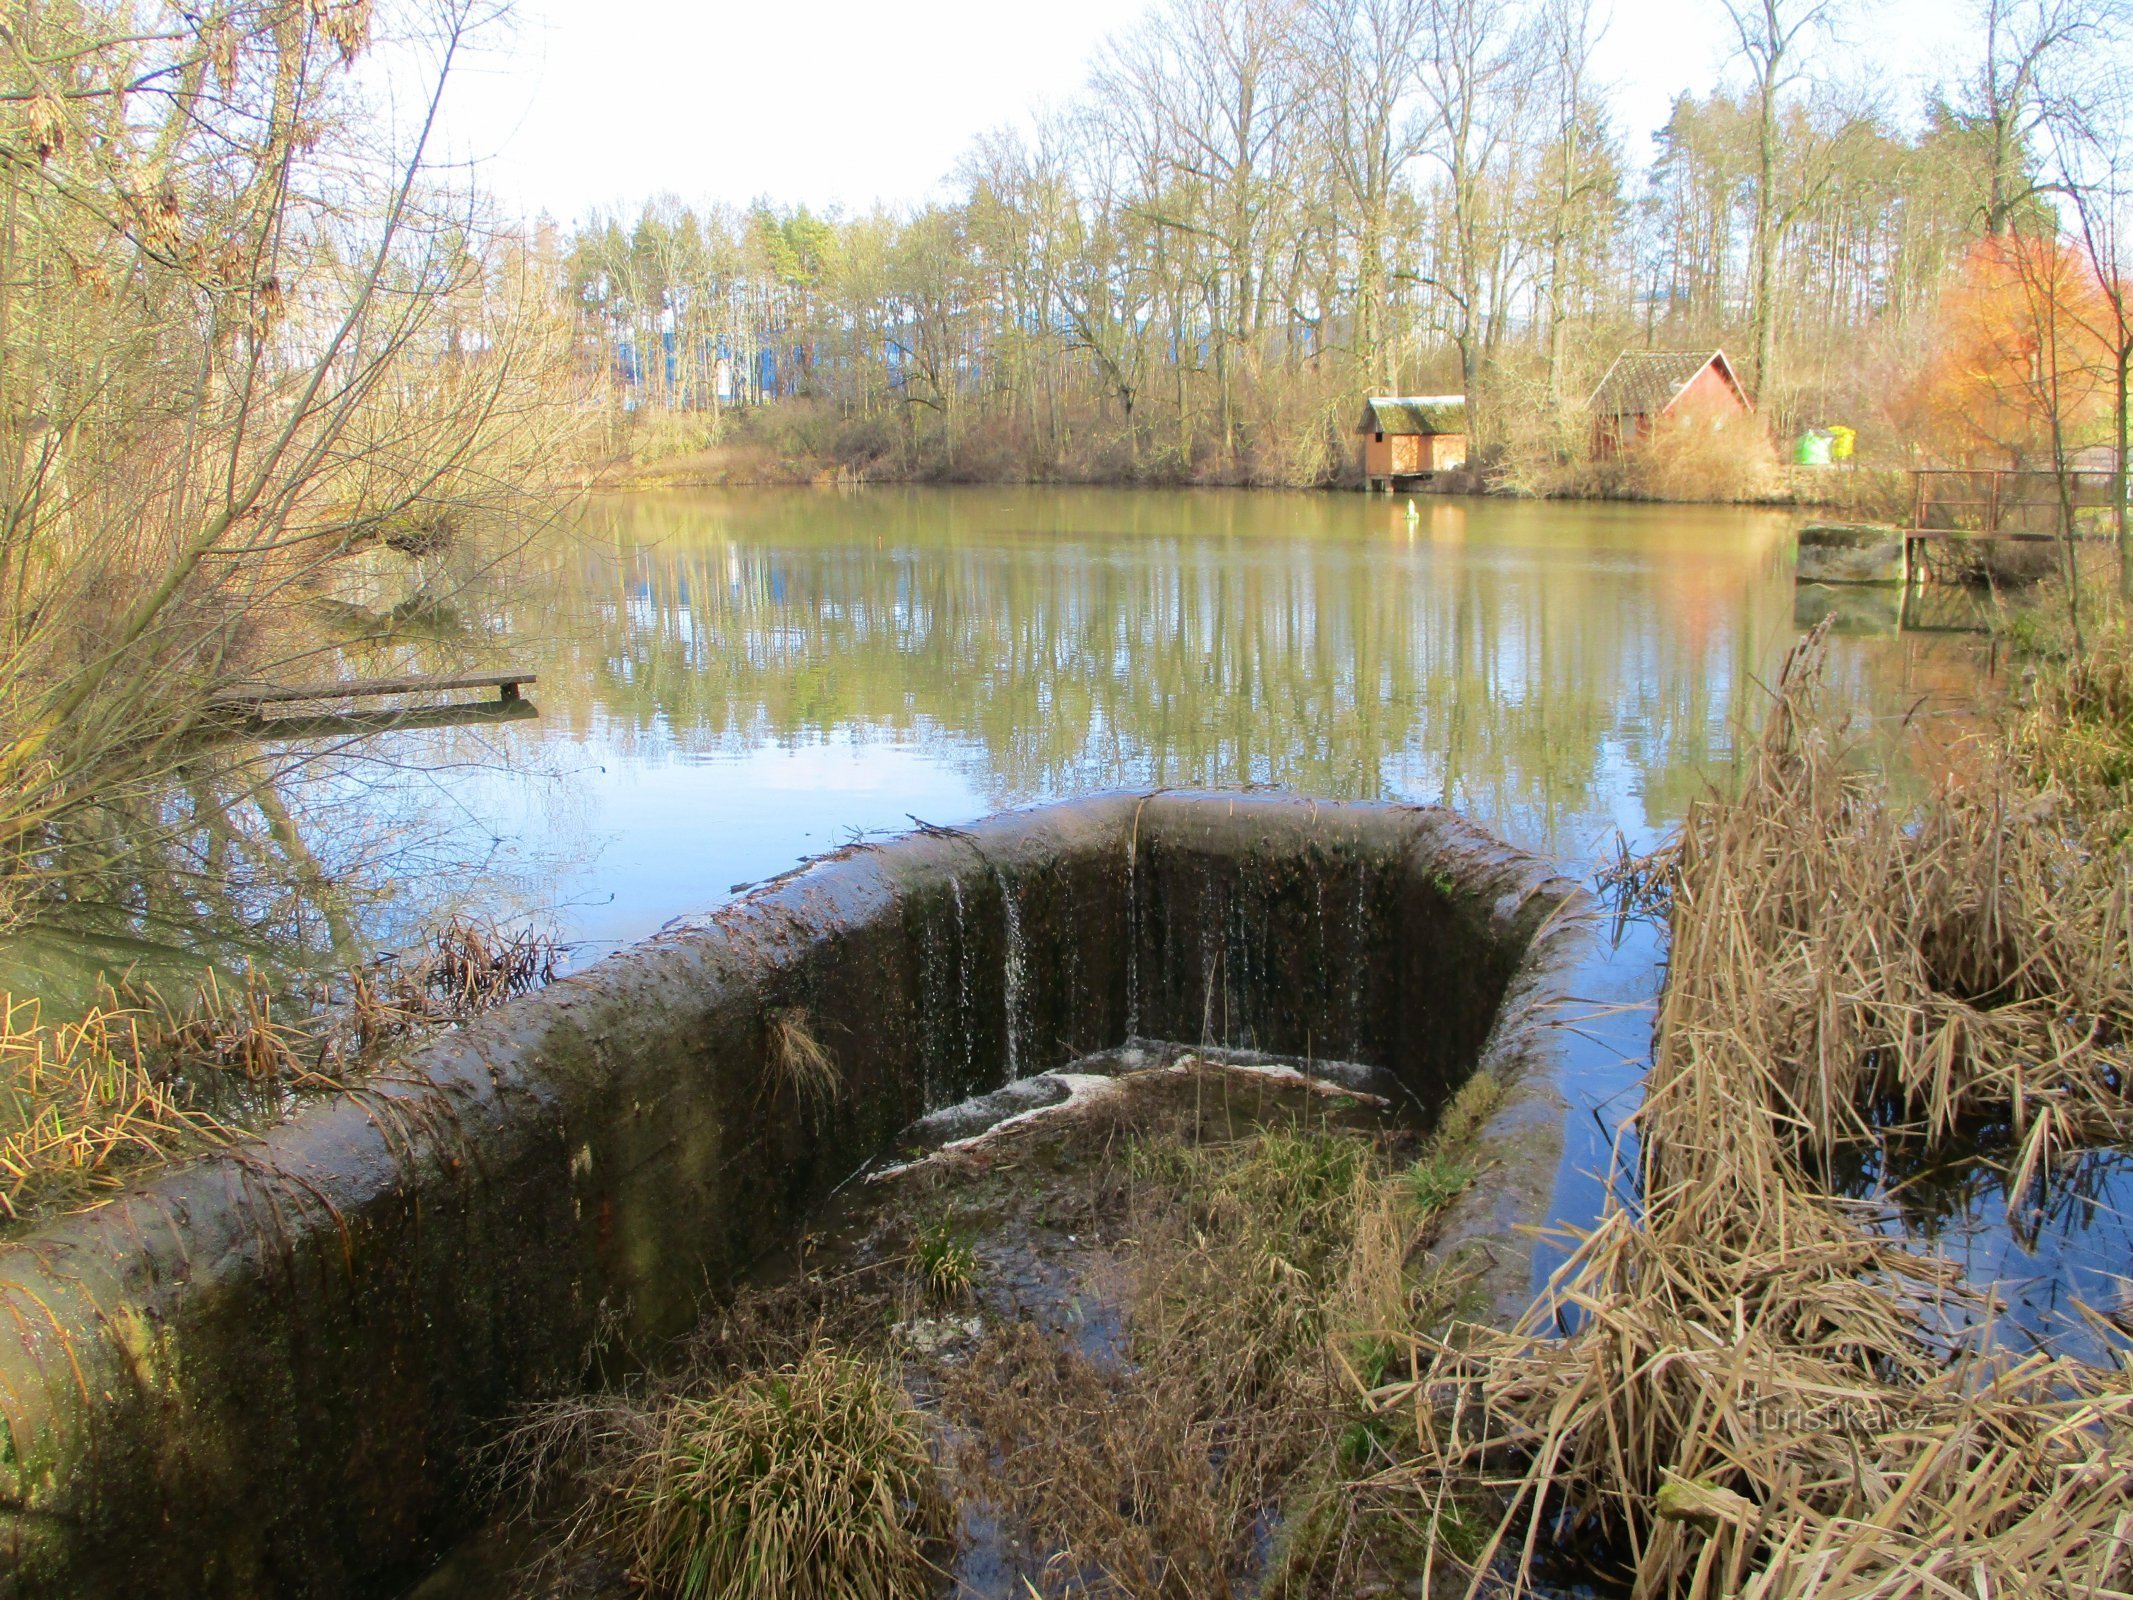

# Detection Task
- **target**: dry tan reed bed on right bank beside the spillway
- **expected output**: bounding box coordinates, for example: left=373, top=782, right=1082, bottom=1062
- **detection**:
left=1357, top=636, right=2133, bottom=1600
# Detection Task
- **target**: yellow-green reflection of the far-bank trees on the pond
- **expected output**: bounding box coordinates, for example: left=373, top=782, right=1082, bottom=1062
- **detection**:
left=499, top=493, right=1851, bottom=843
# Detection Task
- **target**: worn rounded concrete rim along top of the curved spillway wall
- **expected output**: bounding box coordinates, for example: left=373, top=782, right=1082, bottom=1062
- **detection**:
left=0, top=791, right=1576, bottom=1594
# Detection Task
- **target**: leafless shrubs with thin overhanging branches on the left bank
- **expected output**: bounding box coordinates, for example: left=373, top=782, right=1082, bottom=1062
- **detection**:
left=0, top=0, right=580, bottom=938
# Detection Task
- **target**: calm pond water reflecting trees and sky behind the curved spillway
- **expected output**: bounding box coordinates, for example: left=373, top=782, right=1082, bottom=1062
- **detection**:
left=29, top=489, right=2116, bottom=1348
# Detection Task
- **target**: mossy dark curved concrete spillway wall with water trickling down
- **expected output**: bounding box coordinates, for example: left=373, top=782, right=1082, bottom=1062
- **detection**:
left=0, top=794, right=1585, bottom=1600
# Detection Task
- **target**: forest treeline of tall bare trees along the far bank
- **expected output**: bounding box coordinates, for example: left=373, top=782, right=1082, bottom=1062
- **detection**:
left=552, top=0, right=2124, bottom=489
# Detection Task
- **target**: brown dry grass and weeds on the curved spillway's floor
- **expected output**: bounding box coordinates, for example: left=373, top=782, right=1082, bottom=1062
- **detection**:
left=501, top=1069, right=1499, bottom=1600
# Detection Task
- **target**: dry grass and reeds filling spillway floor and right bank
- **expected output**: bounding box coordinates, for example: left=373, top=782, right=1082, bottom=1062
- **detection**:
left=475, top=619, right=2133, bottom=1600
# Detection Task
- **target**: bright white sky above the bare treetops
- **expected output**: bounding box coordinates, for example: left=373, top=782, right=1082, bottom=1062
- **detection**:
left=415, top=0, right=1969, bottom=222
